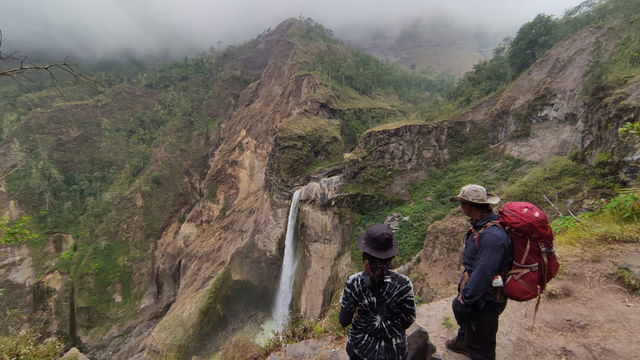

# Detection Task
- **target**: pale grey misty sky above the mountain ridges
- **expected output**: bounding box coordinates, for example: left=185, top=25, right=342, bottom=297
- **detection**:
left=0, top=0, right=581, bottom=57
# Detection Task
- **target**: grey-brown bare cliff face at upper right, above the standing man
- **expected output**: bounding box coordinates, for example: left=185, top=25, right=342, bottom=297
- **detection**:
left=347, top=27, right=639, bottom=196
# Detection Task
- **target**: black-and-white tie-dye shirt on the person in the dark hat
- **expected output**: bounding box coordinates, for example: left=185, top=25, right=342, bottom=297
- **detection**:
left=340, top=270, right=416, bottom=360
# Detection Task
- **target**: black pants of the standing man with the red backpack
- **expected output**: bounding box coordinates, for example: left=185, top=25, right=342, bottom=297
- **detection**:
left=456, top=301, right=507, bottom=360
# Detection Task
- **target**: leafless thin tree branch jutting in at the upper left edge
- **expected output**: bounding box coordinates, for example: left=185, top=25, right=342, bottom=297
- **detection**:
left=0, top=31, right=101, bottom=96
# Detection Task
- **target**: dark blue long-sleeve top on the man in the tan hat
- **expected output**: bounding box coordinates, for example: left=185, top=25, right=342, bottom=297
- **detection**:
left=462, top=212, right=513, bottom=307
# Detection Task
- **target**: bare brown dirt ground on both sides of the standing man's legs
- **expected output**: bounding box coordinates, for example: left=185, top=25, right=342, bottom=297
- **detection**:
left=417, top=244, right=640, bottom=360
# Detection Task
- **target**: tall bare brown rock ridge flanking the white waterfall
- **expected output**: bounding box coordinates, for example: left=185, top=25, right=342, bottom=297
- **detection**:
left=130, top=21, right=358, bottom=358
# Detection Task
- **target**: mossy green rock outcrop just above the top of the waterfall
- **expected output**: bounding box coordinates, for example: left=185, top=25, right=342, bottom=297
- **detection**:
left=279, top=116, right=344, bottom=181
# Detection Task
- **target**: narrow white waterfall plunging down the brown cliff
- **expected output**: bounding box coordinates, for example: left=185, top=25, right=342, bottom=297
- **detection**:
left=273, top=189, right=302, bottom=331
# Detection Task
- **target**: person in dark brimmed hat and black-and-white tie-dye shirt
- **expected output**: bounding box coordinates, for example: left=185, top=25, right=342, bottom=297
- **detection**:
left=340, top=224, right=416, bottom=360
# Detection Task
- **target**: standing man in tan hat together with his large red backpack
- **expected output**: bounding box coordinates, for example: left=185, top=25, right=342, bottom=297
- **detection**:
left=445, top=185, right=560, bottom=360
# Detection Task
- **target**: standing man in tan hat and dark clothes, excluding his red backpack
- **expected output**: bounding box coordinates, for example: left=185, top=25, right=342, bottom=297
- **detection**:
left=445, top=185, right=513, bottom=360
